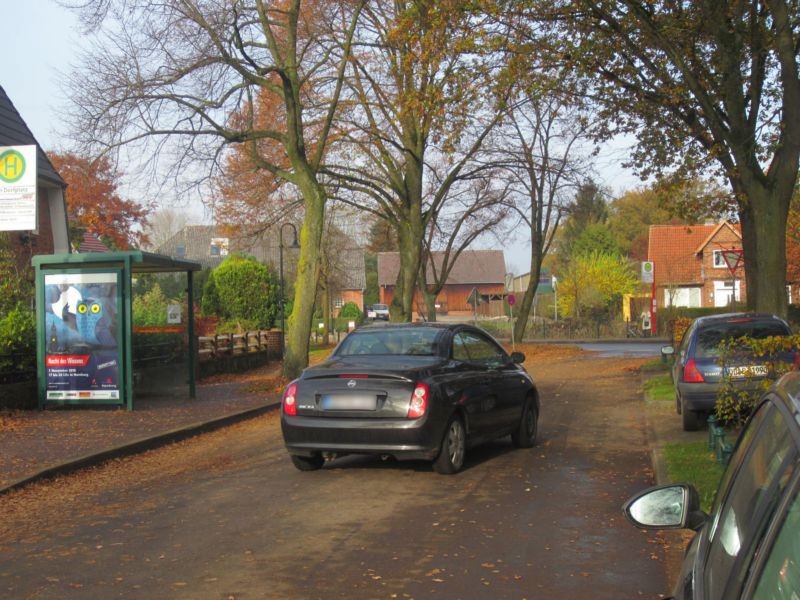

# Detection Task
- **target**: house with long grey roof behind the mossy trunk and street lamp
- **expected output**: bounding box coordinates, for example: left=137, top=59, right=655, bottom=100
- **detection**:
left=156, top=225, right=366, bottom=317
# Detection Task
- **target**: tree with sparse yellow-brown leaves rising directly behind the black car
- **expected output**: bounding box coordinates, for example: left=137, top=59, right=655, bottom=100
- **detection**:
left=328, top=0, right=501, bottom=321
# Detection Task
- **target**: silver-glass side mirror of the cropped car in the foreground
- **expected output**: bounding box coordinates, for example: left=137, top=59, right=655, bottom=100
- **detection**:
left=622, top=483, right=708, bottom=530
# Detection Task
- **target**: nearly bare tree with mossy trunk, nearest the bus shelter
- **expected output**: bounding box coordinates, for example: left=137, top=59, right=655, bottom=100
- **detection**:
left=61, top=0, right=365, bottom=377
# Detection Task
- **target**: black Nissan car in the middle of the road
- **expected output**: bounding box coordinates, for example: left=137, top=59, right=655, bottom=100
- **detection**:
left=281, top=323, right=539, bottom=474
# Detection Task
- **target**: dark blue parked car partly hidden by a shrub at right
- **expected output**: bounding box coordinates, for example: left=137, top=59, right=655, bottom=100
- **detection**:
left=661, top=313, right=795, bottom=431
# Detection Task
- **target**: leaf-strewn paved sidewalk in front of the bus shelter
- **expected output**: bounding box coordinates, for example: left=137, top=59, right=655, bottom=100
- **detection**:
left=0, top=363, right=281, bottom=495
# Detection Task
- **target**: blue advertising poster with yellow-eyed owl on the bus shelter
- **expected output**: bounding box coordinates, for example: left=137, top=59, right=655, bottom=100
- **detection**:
left=44, top=272, right=121, bottom=401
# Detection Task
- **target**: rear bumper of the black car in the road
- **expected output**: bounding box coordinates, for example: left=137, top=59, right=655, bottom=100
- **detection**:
left=281, top=415, right=443, bottom=460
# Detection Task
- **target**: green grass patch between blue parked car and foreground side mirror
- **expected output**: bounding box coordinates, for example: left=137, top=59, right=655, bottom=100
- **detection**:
left=664, top=440, right=724, bottom=512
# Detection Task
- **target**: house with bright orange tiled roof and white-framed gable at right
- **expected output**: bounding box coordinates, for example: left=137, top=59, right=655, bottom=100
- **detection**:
left=647, top=221, right=747, bottom=308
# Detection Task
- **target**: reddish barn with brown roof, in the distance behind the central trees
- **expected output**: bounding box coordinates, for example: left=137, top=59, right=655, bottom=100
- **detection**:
left=378, top=250, right=506, bottom=317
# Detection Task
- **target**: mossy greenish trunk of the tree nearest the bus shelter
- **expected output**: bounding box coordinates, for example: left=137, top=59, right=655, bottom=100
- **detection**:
left=283, top=180, right=326, bottom=379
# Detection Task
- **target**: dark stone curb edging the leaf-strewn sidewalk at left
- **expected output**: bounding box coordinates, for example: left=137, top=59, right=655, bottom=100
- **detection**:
left=0, top=402, right=280, bottom=496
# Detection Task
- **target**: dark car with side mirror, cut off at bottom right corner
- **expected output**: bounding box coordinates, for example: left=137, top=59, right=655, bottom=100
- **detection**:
left=624, top=371, right=800, bottom=600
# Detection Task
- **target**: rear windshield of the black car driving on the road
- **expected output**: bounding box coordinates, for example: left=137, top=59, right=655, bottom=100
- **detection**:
left=336, top=327, right=442, bottom=356
